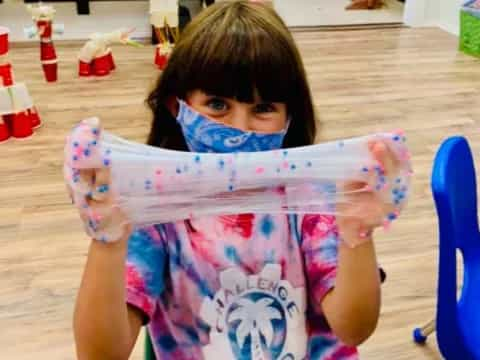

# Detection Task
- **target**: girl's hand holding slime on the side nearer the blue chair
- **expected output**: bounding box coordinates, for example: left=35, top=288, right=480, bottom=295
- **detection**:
left=337, top=141, right=399, bottom=247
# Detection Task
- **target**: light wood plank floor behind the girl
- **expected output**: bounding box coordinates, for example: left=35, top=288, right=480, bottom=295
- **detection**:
left=0, top=28, right=480, bottom=360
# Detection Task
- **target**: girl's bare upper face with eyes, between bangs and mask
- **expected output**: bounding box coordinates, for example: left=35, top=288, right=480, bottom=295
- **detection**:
left=186, top=90, right=287, bottom=133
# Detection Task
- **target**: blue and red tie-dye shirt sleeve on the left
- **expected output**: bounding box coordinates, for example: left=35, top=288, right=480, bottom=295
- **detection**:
left=125, top=226, right=165, bottom=323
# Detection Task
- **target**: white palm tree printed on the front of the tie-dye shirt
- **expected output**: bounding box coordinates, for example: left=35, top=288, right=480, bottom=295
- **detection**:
left=228, top=297, right=282, bottom=360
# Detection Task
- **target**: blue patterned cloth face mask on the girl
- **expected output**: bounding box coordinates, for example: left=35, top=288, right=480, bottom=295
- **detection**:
left=177, top=100, right=288, bottom=153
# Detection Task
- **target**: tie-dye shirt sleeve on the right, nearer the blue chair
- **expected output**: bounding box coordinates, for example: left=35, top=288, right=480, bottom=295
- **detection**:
left=299, top=214, right=339, bottom=311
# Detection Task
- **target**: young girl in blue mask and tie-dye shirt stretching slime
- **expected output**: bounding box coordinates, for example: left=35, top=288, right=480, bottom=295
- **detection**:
left=74, top=1, right=395, bottom=360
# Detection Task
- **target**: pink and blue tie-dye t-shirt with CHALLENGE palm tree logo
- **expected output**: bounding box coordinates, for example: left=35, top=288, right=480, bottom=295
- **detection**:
left=126, top=214, right=358, bottom=360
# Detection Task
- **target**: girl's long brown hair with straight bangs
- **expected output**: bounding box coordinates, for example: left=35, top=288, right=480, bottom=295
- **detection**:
left=147, top=1, right=316, bottom=150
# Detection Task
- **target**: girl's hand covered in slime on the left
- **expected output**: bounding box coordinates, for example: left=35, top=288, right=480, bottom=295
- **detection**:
left=68, top=167, right=132, bottom=242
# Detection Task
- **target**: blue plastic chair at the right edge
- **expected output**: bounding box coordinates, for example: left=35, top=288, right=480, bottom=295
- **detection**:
left=414, top=137, right=480, bottom=360
